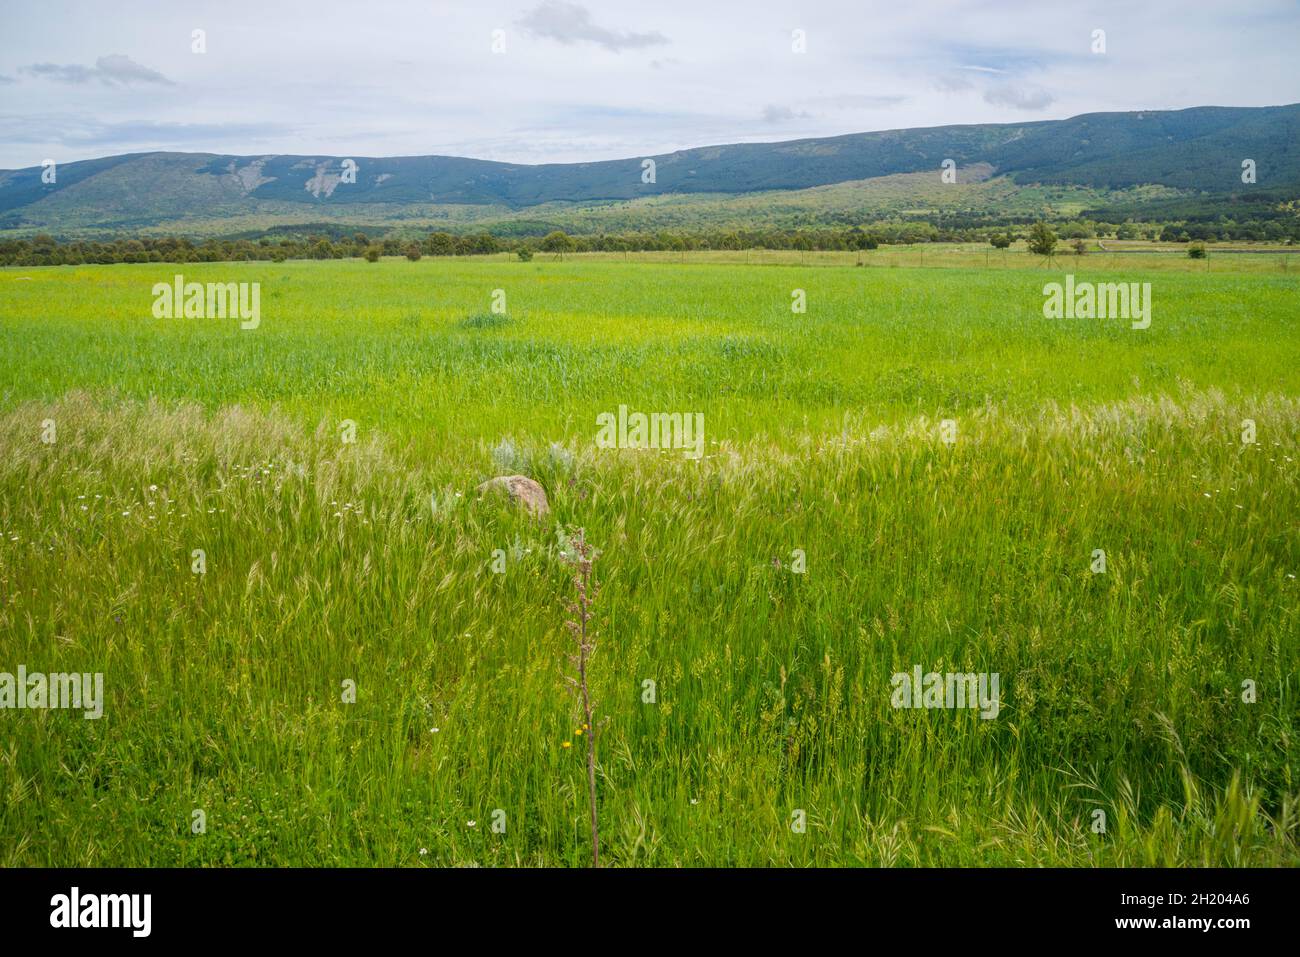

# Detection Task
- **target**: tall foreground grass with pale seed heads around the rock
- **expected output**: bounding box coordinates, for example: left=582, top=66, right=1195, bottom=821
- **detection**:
left=0, top=389, right=1300, bottom=866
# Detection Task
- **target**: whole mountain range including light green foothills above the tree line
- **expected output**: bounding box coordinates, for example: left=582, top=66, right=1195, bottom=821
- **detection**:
left=0, top=104, right=1300, bottom=235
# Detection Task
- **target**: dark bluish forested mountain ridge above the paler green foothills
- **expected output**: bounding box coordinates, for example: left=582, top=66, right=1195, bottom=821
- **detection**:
left=0, top=104, right=1300, bottom=230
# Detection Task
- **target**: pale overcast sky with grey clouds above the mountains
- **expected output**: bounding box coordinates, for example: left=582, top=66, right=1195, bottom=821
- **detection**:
left=0, top=0, right=1300, bottom=168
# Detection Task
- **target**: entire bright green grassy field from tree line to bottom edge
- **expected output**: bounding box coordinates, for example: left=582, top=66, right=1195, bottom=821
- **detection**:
left=0, top=254, right=1300, bottom=866
